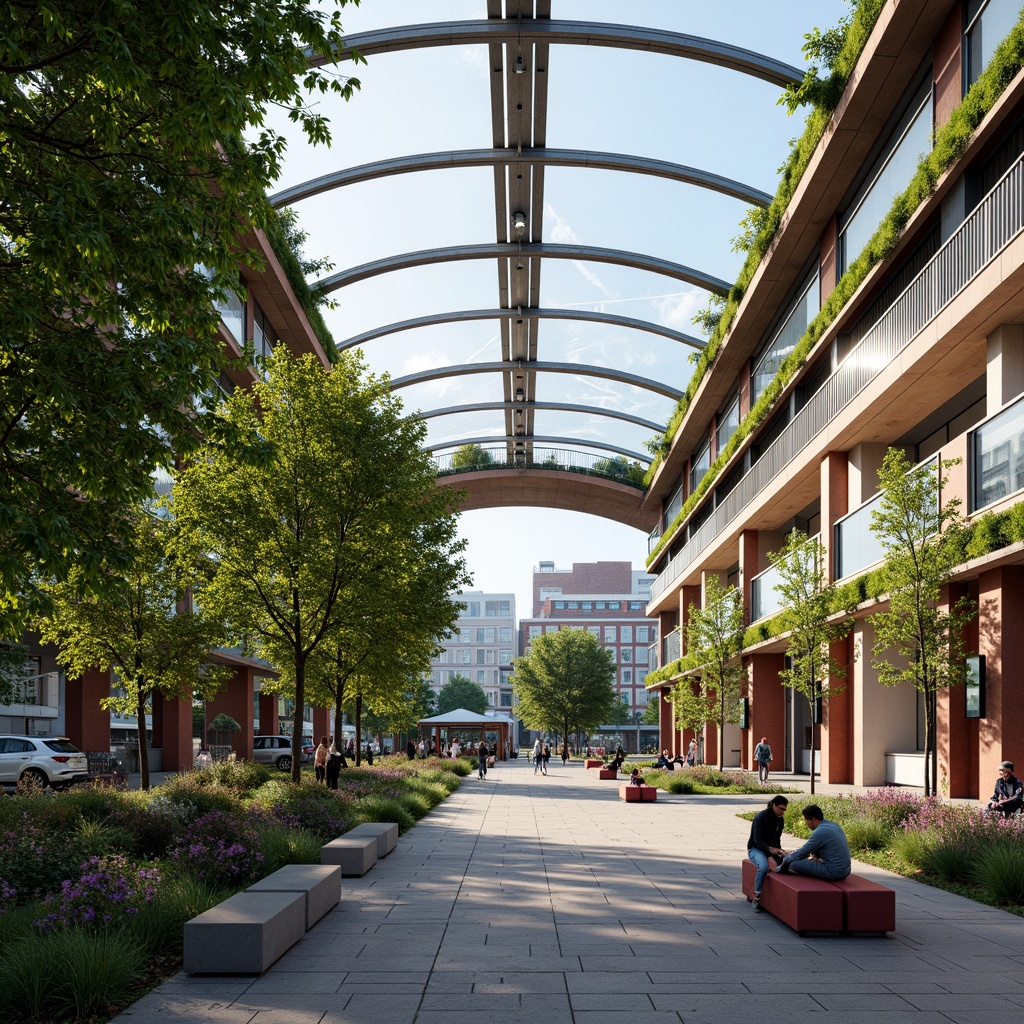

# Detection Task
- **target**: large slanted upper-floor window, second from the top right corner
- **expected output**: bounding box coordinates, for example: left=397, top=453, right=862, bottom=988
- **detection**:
left=839, top=76, right=932, bottom=273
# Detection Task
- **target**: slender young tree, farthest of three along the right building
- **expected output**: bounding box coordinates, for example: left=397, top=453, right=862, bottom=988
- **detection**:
left=673, top=575, right=744, bottom=767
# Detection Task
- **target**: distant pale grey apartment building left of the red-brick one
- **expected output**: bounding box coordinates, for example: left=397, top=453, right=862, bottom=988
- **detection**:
left=430, top=590, right=517, bottom=717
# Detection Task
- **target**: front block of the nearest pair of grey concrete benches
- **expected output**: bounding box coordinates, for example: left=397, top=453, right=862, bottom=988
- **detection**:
left=182, top=892, right=306, bottom=974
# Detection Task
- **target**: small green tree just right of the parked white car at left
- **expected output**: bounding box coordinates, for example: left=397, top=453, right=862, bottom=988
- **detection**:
left=40, top=512, right=227, bottom=790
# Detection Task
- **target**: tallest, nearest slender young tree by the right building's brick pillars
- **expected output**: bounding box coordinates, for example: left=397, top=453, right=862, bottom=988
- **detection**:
left=869, top=449, right=977, bottom=796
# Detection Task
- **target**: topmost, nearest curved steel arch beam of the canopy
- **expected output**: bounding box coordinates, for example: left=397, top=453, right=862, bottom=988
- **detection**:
left=307, top=18, right=804, bottom=88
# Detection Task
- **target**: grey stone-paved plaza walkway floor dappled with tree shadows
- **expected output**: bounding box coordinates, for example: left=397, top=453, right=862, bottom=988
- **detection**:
left=115, top=761, right=1024, bottom=1024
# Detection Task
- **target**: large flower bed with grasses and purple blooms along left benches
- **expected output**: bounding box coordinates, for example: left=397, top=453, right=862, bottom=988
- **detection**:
left=0, top=757, right=460, bottom=1024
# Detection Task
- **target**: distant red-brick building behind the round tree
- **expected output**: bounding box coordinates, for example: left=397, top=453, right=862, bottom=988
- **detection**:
left=519, top=562, right=657, bottom=746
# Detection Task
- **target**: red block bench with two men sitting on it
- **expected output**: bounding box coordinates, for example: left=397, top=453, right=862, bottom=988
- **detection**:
left=742, top=860, right=896, bottom=934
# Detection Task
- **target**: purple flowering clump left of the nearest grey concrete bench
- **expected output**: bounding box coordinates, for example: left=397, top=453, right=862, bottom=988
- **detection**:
left=35, top=854, right=160, bottom=932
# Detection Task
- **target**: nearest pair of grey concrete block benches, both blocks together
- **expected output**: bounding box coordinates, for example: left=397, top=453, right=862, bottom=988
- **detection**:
left=182, top=864, right=341, bottom=974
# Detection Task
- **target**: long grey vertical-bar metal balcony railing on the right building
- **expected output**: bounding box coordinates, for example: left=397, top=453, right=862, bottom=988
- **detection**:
left=651, top=148, right=1024, bottom=600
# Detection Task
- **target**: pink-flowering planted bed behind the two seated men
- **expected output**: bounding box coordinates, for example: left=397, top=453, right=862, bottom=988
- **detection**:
left=742, top=786, right=1024, bottom=915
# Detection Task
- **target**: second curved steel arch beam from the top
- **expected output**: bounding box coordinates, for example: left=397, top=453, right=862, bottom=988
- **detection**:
left=270, top=148, right=771, bottom=207
